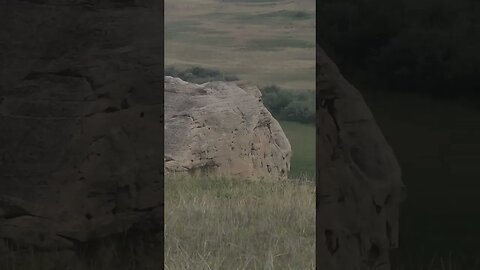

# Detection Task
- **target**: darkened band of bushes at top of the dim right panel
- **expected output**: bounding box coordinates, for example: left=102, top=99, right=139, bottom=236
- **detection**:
left=317, top=0, right=480, bottom=98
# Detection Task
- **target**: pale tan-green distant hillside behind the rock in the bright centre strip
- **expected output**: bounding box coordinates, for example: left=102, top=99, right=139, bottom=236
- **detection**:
left=165, top=0, right=315, bottom=89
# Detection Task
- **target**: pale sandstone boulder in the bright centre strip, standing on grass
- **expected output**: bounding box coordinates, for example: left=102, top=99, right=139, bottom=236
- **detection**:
left=165, top=76, right=291, bottom=179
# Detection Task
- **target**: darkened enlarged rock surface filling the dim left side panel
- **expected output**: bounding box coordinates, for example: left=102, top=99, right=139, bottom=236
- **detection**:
left=0, top=0, right=163, bottom=260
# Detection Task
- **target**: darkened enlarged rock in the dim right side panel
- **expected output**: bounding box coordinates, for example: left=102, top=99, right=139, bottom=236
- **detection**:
left=317, top=48, right=405, bottom=270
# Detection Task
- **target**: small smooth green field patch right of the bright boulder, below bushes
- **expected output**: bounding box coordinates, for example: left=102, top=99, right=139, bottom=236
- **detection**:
left=280, top=121, right=315, bottom=179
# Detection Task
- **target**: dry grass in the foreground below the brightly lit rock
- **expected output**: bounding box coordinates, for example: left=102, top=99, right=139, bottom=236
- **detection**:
left=165, top=176, right=315, bottom=270
